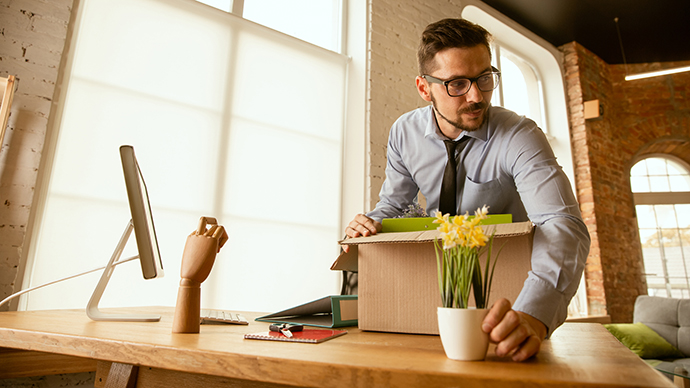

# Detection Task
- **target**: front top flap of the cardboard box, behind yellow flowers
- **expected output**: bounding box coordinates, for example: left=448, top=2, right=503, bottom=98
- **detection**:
left=334, top=221, right=534, bottom=246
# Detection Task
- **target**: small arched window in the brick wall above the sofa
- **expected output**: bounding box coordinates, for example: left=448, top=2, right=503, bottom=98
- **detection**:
left=630, top=155, right=690, bottom=298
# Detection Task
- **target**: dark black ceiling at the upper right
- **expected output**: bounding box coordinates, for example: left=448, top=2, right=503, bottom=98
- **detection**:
left=483, top=0, right=690, bottom=64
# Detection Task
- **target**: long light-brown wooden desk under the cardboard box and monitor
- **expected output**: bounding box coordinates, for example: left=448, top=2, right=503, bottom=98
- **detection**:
left=0, top=307, right=673, bottom=388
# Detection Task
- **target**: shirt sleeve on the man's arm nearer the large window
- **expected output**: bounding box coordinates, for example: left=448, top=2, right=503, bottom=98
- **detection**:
left=367, top=121, right=419, bottom=222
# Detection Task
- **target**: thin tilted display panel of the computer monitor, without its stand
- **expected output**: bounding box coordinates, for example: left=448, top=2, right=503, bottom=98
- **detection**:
left=120, top=145, right=163, bottom=279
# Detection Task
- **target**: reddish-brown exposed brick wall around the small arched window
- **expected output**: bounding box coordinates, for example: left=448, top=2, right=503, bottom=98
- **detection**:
left=561, top=43, right=690, bottom=322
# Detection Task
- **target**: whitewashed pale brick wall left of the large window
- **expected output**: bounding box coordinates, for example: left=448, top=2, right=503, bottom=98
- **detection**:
left=0, top=0, right=73, bottom=310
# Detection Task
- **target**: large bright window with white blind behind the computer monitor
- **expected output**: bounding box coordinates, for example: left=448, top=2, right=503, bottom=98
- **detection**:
left=20, top=0, right=348, bottom=311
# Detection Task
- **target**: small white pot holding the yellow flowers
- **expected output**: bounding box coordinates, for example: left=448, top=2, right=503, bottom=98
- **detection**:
left=438, top=307, right=489, bottom=361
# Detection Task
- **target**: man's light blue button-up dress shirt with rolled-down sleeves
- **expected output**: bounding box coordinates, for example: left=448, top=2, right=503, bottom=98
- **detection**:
left=367, top=106, right=590, bottom=335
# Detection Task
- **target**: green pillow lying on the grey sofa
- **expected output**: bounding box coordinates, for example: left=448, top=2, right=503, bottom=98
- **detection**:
left=604, top=322, right=684, bottom=358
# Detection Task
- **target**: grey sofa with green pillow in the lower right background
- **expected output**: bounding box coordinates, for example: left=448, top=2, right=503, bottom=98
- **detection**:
left=604, top=295, right=690, bottom=378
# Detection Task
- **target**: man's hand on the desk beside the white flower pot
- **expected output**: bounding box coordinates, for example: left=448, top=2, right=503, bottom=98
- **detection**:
left=482, top=299, right=546, bottom=361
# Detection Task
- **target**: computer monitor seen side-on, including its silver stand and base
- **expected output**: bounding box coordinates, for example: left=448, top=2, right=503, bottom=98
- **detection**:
left=86, top=145, right=164, bottom=321
